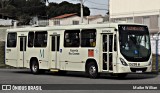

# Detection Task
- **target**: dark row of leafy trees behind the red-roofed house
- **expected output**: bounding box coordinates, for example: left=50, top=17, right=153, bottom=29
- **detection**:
left=0, top=0, right=90, bottom=25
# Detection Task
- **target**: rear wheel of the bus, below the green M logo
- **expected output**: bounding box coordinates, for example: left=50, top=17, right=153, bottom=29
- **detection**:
left=30, top=60, right=40, bottom=74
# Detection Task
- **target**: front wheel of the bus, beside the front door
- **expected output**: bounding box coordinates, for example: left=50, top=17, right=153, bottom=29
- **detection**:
left=86, top=62, right=99, bottom=78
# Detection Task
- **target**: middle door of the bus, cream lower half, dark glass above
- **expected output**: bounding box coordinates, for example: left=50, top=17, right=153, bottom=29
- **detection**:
left=50, top=34, right=60, bottom=69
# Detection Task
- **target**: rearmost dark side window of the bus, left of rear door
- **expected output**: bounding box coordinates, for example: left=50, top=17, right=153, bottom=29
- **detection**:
left=7, top=33, right=17, bottom=47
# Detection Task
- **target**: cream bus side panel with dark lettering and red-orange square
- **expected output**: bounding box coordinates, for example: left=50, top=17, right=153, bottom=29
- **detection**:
left=60, top=48, right=99, bottom=71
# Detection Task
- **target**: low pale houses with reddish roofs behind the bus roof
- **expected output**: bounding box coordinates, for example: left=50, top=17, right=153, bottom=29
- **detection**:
left=49, top=13, right=103, bottom=26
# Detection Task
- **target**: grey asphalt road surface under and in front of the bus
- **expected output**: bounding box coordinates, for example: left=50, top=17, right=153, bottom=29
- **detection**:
left=0, top=69, right=160, bottom=93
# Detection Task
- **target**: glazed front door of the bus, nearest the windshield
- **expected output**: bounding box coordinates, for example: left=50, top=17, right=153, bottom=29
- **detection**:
left=102, top=34, right=113, bottom=72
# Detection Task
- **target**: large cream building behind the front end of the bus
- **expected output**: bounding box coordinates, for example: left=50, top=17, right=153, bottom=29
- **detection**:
left=109, top=0, right=160, bottom=54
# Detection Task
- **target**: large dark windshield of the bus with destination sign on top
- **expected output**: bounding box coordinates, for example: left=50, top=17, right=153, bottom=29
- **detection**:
left=119, top=25, right=151, bottom=62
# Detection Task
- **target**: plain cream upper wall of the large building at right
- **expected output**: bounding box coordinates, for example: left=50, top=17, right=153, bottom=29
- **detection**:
left=109, top=0, right=160, bottom=18
